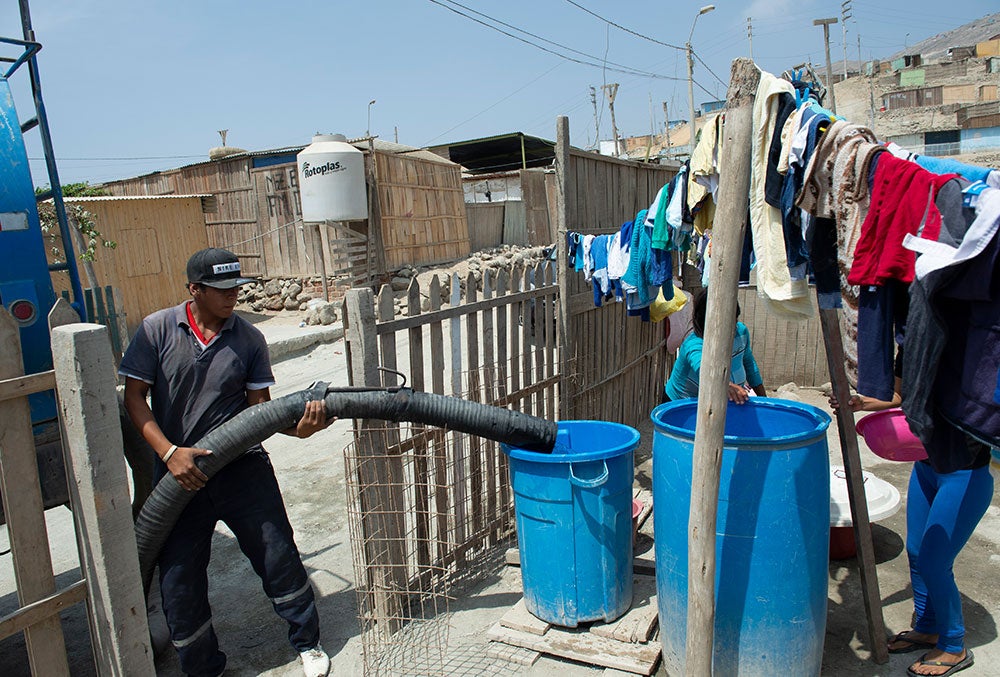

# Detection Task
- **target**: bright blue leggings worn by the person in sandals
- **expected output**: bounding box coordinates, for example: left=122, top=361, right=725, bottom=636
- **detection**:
left=906, top=462, right=993, bottom=653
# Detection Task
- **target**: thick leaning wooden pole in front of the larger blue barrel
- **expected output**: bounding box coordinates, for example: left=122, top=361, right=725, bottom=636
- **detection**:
left=685, top=58, right=760, bottom=677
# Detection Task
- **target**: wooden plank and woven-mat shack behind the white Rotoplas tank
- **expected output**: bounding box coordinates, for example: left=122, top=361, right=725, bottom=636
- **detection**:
left=102, top=139, right=470, bottom=286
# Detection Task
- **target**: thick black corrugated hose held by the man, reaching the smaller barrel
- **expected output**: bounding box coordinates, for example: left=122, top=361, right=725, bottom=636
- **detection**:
left=135, top=384, right=557, bottom=592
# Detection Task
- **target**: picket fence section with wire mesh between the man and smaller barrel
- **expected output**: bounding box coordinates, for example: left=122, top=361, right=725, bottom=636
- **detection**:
left=345, top=266, right=559, bottom=675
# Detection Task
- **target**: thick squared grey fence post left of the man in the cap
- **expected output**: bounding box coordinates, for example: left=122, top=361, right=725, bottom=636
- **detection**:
left=52, top=324, right=154, bottom=675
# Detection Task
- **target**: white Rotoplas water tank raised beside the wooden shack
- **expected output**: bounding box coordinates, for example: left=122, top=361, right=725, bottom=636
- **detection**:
left=296, top=134, right=368, bottom=222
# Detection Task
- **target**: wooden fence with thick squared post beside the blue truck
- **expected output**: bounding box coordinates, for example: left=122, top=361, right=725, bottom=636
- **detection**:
left=0, top=300, right=154, bottom=677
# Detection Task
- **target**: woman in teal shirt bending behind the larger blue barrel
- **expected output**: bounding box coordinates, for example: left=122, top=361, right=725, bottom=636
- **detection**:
left=663, top=289, right=767, bottom=404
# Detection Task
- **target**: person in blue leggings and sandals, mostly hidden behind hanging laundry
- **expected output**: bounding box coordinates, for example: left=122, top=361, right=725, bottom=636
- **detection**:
left=830, top=349, right=993, bottom=677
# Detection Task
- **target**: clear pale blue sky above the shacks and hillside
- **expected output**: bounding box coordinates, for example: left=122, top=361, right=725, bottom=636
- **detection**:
left=0, top=0, right=1000, bottom=183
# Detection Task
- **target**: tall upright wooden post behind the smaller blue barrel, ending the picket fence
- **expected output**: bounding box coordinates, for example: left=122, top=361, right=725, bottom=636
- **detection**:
left=556, top=115, right=574, bottom=420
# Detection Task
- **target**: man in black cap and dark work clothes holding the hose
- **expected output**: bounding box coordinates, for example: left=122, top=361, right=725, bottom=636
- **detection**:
left=119, top=248, right=332, bottom=677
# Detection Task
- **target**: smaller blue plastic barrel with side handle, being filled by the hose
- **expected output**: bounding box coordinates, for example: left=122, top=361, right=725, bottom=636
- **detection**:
left=503, top=421, right=639, bottom=628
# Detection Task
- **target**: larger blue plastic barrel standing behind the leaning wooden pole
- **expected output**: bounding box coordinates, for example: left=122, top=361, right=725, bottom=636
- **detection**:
left=652, top=397, right=830, bottom=676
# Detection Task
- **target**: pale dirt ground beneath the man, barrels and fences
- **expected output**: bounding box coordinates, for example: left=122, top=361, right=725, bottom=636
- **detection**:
left=0, top=314, right=1000, bottom=677
